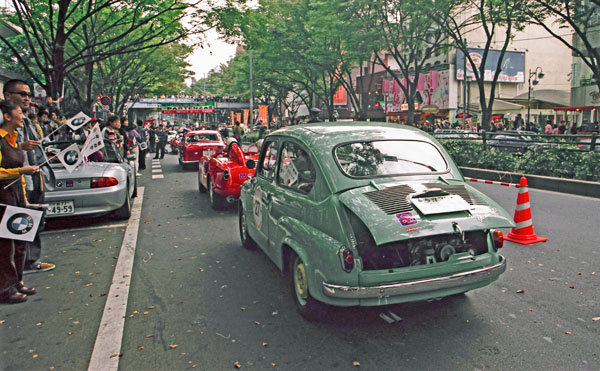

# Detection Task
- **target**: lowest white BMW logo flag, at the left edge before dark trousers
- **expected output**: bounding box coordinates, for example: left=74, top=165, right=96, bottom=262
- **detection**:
left=0, top=204, right=42, bottom=242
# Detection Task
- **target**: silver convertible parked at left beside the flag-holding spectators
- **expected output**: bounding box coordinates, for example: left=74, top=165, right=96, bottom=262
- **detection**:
left=45, top=141, right=137, bottom=219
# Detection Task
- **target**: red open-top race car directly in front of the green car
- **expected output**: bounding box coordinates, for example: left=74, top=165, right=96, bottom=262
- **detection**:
left=198, top=141, right=259, bottom=210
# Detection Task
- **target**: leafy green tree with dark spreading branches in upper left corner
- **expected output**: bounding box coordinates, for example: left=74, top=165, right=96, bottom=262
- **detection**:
left=0, top=0, right=188, bottom=103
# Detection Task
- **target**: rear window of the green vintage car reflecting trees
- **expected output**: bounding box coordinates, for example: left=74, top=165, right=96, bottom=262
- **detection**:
left=334, top=140, right=449, bottom=178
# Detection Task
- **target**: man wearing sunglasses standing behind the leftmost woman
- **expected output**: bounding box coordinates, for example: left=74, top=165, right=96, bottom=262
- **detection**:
left=2, top=80, right=54, bottom=274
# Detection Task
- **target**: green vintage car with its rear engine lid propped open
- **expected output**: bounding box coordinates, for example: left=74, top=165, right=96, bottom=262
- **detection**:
left=239, top=122, right=514, bottom=319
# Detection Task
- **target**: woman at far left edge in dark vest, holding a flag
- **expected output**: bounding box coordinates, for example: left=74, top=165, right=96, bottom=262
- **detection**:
left=0, top=101, right=38, bottom=304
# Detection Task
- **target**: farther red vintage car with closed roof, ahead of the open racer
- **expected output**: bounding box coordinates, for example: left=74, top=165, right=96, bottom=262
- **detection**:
left=179, top=130, right=225, bottom=169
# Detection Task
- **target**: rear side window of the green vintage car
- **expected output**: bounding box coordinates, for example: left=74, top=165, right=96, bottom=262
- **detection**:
left=277, top=142, right=317, bottom=193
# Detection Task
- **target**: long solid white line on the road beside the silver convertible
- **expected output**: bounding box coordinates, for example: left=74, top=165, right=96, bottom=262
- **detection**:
left=88, top=187, right=144, bottom=371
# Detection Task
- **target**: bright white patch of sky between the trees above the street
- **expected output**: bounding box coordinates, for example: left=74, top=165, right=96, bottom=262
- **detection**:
left=188, top=32, right=236, bottom=79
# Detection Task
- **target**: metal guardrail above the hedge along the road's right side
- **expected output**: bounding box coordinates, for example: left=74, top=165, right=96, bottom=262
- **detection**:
left=431, top=130, right=600, bottom=152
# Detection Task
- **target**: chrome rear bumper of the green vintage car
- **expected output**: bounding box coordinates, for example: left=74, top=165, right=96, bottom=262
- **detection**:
left=323, top=256, right=506, bottom=299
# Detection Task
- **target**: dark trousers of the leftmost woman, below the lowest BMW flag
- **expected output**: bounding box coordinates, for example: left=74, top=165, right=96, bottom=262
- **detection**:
left=0, top=238, right=27, bottom=292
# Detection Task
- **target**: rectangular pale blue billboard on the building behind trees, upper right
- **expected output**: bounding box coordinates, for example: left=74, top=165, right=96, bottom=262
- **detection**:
left=456, top=48, right=525, bottom=83
